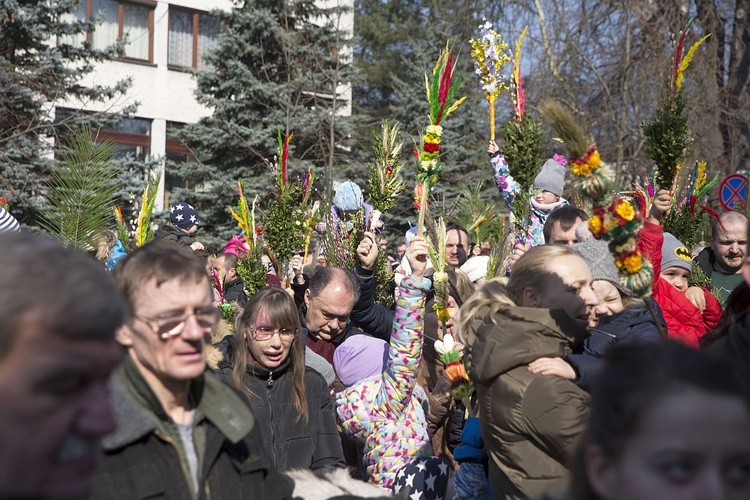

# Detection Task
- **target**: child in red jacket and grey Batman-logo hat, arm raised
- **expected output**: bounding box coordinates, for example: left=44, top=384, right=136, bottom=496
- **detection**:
left=638, top=189, right=721, bottom=348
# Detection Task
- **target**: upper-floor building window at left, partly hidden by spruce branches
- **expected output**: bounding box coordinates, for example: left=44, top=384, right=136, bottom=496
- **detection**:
left=68, top=0, right=156, bottom=61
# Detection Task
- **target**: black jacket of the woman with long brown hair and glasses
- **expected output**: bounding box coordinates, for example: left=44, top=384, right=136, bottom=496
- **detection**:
left=223, top=364, right=346, bottom=471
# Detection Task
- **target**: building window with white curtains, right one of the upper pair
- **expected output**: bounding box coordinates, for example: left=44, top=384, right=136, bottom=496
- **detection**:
left=169, top=6, right=219, bottom=70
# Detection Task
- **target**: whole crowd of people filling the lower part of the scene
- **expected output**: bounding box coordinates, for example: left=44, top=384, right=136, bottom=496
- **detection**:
left=0, top=150, right=750, bottom=500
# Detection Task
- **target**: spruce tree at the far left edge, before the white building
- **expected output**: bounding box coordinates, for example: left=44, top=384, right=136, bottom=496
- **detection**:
left=0, top=0, right=129, bottom=224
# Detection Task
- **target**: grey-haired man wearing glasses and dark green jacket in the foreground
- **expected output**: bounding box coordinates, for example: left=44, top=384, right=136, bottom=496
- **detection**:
left=92, top=241, right=293, bottom=499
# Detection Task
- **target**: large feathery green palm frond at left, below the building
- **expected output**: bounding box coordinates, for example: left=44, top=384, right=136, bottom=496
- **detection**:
left=40, top=128, right=117, bottom=252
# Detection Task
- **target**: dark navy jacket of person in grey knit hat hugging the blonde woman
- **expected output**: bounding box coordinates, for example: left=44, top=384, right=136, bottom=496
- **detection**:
left=564, top=299, right=667, bottom=391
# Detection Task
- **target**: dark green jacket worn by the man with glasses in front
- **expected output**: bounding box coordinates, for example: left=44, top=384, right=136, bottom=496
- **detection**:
left=91, top=356, right=294, bottom=500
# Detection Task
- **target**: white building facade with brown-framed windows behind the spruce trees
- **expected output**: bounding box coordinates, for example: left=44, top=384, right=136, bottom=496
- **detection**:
left=58, top=0, right=354, bottom=210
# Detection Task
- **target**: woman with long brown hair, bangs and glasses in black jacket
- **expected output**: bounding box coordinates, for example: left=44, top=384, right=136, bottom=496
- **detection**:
left=229, top=287, right=345, bottom=471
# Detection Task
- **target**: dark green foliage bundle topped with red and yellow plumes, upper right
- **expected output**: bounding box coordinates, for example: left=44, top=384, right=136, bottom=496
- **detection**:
left=642, top=91, right=693, bottom=189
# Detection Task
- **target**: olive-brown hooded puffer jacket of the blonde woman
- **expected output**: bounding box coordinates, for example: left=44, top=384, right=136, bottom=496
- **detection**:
left=470, top=307, right=589, bottom=498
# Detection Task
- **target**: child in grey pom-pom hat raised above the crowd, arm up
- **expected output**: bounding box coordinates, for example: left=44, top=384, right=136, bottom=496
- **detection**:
left=487, top=141, right=568, bottom=249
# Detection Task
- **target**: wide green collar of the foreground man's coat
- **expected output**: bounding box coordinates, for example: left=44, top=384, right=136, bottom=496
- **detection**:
left=102, top=355, right=255, bottom=450
